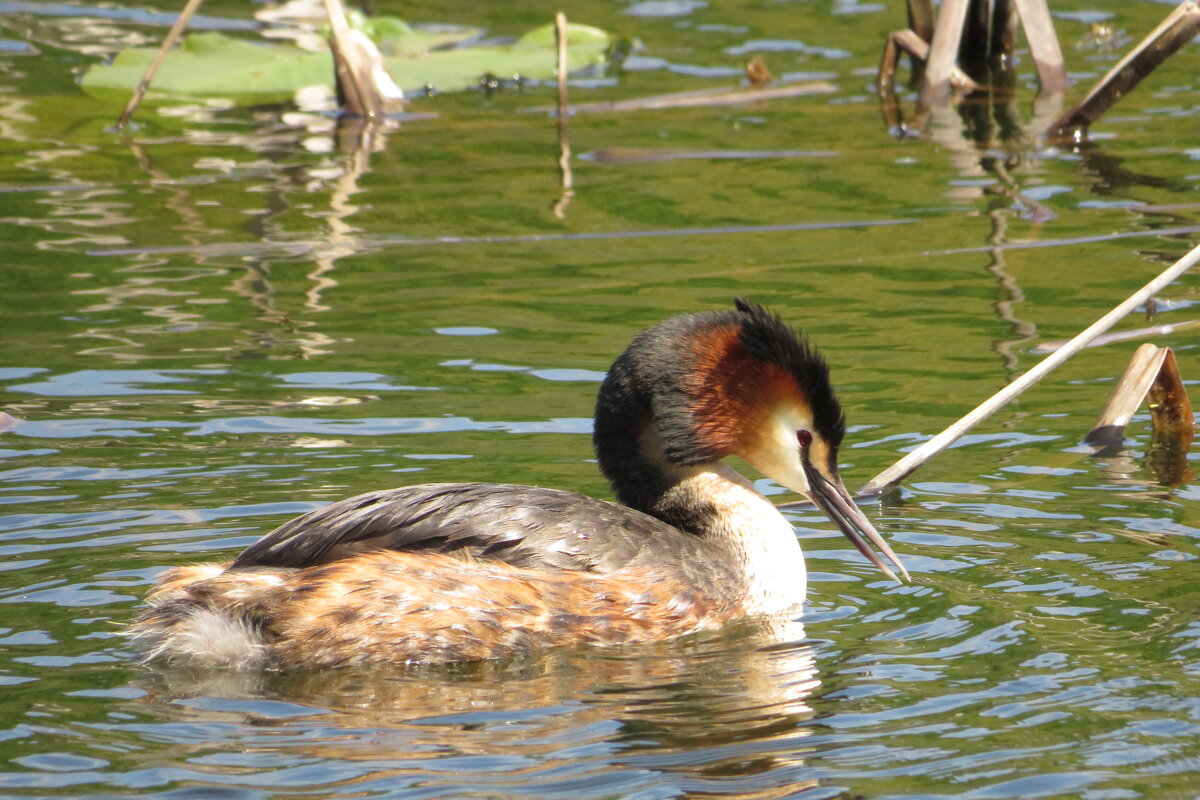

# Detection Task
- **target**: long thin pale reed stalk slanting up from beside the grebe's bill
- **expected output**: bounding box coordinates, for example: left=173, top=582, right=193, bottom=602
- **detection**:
left=858, top=245, right=1200, bottom=495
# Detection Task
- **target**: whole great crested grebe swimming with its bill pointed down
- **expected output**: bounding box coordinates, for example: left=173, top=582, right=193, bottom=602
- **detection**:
left=128, top=300, right=908, bottom=668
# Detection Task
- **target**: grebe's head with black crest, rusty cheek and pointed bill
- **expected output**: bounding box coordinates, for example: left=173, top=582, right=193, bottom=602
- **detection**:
left=595, top=299, right=908, bottom=579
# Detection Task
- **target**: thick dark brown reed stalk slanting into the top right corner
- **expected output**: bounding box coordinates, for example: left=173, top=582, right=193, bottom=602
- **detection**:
left=1046, top=0, right=1200, bottom=139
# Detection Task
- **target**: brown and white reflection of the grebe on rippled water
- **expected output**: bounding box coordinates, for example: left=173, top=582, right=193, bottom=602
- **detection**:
left=101, top=622, right=818, bottom=798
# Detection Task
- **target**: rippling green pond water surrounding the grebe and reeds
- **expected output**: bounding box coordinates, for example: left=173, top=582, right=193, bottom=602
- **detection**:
left=0, top=0, right=1200, bottom=800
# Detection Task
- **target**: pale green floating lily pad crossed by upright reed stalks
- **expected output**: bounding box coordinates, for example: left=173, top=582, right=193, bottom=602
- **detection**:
left=82, top=20, right=612, bottom=106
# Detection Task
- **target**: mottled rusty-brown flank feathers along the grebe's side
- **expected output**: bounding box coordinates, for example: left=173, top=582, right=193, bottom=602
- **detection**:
left=131, top=551, right=744, bottom=667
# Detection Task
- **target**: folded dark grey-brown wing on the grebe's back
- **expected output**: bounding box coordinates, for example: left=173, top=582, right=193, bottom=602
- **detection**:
left=233, top=483, right=700, bottom=573
